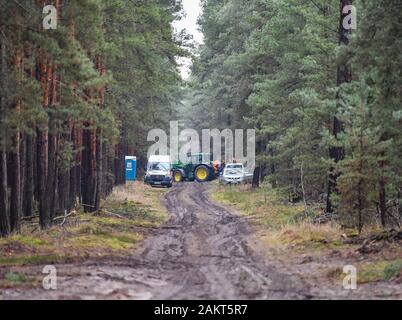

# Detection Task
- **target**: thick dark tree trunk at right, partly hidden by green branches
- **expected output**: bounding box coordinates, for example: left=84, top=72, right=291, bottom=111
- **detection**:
left=326, top=0, right=352, bottom=213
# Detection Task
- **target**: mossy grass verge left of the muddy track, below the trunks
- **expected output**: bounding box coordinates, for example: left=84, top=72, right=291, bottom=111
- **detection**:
left=0, top=182, right=168, bottom=268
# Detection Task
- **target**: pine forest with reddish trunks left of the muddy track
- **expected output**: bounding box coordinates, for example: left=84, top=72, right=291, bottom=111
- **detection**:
left=0, top=0, right=187, bottom=236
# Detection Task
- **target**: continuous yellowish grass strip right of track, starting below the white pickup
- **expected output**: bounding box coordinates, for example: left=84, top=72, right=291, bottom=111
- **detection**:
left=212, top=184, right=344, bottom=250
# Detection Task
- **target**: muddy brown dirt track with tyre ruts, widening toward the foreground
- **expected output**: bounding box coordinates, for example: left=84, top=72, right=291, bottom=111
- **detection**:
left=4, top=183, right=310, bottom=299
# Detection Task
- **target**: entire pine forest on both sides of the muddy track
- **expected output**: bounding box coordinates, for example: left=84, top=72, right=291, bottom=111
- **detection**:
left=0, top=0, right=402, bottom=236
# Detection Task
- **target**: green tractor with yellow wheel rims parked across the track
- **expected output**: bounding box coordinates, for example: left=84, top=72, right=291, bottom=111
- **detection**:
left=172, top=153, right=218, bottom=182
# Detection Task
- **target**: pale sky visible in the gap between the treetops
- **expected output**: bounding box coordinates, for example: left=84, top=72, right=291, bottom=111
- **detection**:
left=174, top=0, right=203, bottom=79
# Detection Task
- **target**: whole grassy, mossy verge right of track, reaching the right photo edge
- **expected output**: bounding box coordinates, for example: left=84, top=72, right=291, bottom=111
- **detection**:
left=212, top=184, right=402, bottom=284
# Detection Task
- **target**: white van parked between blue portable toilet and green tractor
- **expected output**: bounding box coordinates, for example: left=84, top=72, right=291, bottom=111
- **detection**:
left=144, top=156, right=173, bottom=188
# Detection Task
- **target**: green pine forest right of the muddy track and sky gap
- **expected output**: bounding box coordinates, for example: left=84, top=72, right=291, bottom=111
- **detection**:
left=184, top=0, right=402, bottom=230
